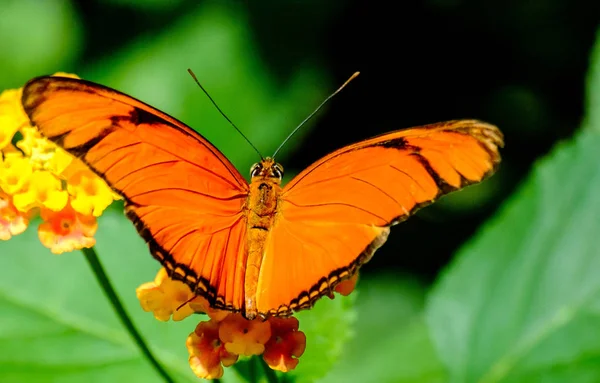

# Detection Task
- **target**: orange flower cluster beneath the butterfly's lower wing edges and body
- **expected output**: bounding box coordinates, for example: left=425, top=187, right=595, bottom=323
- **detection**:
left=137, top=269, right=357, bottom=379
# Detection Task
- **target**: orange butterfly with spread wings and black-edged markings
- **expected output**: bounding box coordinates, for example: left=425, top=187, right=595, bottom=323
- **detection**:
left=22, top=76, right=503, bottom=319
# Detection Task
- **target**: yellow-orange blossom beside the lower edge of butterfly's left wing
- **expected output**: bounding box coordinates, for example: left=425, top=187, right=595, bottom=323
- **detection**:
left=136, top=268, right=194, bottom=322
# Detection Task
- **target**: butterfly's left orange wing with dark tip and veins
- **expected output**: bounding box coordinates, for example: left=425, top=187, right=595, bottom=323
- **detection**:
left=23, top=77, right=248, bottom=310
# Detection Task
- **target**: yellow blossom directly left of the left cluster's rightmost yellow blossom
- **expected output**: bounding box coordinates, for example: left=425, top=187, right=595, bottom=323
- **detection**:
left=13, top=170, right=69, bottom=211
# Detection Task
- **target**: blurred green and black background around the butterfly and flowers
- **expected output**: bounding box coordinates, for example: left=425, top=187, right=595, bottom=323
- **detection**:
left=0, top=0, right=600, bottom=383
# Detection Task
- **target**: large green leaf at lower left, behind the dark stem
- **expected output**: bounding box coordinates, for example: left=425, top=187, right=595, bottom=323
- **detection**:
left=0, top=210, right=244, bottom=383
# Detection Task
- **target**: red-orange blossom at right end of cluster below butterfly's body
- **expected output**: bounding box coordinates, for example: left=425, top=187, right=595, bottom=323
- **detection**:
left=263, top=317, right=306, bottom=372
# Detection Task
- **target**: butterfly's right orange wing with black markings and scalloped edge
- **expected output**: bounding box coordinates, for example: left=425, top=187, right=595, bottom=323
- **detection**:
left=256, top=120, right=503, bottom=315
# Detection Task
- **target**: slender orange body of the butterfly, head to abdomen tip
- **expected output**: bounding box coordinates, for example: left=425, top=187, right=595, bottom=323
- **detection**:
left=244, top=157, right=283, bottom=319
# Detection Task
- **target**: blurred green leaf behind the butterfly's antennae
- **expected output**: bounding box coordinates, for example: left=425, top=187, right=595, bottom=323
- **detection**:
left=83, top=2, right=331, bottom=175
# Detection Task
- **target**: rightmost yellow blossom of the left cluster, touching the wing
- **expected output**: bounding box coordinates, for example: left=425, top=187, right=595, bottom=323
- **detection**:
left=67, top=169, right=113, bottom=217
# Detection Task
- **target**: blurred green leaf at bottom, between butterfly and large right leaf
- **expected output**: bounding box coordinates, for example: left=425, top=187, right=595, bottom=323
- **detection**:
left=320, top=275, right=445, bottom=383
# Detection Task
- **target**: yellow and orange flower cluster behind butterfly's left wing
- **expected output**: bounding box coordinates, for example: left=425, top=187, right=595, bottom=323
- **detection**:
left=0, top=74, right=118, bottom=254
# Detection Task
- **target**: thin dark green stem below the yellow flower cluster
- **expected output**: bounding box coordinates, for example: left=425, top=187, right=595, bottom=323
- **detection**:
left=81, top=247, right=174, bottom=383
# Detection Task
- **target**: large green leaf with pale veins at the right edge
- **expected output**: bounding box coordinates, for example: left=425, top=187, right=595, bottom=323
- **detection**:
left=427, top=129, right=600, bottom=383
